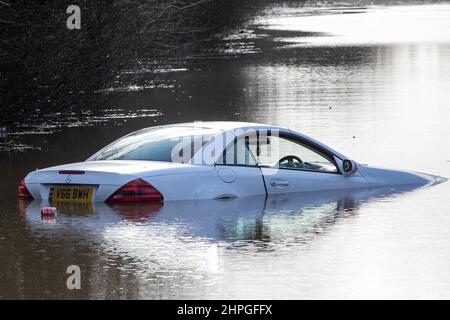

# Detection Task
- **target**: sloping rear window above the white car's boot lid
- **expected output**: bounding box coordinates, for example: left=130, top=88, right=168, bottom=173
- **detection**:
left=87, top=126, right=221, bottom=163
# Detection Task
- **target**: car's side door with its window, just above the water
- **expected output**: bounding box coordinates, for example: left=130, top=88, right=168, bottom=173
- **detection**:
left=250, top=134, right=369, bottom=195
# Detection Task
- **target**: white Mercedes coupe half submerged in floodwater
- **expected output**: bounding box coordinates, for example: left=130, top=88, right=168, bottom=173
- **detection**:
left=18, top=122, right=446, bottom=202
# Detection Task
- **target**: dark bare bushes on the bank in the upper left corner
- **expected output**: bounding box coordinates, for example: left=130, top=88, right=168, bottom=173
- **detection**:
left=0, top=0, right=286, bottom=126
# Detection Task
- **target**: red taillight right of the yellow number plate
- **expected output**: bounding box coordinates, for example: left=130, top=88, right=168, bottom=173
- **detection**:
left=106, top=179, right=163, bottom=202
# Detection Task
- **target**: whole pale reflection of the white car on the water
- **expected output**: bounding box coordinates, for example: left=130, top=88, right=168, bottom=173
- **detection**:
left=16, top=186, right=428, bottom=278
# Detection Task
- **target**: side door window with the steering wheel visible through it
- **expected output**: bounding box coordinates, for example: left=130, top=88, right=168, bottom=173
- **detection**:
left=249, top=136, right=338, bottom=172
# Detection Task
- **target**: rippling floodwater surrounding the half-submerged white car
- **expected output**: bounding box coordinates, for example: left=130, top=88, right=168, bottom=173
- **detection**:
left=0, top=5, right=450, bottom=299
